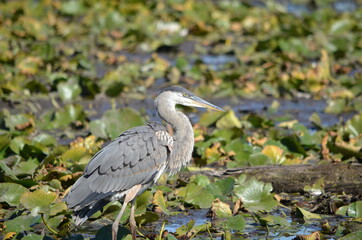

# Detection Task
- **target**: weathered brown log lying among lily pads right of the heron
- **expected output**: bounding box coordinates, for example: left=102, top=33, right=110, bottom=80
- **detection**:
left=184, top=163, right=362, bottom=194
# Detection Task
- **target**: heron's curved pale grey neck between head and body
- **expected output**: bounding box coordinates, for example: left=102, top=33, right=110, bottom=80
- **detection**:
left=157, top=96, right=194, bottom=174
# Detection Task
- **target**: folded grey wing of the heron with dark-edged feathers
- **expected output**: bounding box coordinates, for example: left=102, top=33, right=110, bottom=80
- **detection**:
left=66, top=123, right=172, bottom=208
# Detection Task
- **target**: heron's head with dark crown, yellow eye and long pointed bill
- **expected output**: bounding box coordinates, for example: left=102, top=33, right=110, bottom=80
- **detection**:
left=159, top=86, right=224, bottom=111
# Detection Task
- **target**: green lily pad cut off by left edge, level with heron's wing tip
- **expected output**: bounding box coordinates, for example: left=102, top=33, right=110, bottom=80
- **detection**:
left=0, top=183, right=28, bottom=206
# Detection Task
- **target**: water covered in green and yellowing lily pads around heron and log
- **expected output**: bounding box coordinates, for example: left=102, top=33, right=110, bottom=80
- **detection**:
left=0, top=0, right=362, bottom=239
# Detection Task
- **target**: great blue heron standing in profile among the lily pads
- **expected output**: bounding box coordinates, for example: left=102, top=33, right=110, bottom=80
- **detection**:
left=65, top=86, right=223, bottom=240
